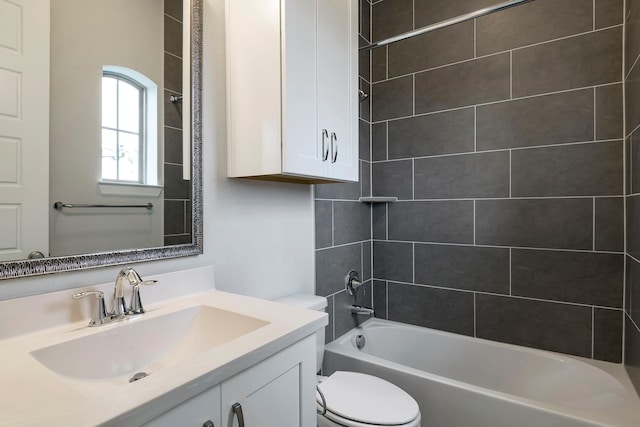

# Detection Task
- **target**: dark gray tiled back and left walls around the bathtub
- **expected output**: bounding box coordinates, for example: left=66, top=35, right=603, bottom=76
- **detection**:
left=315, top=0, right=640, bottom=366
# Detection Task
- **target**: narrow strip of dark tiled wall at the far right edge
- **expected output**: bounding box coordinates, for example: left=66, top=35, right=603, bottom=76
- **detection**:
left=624, top=0, right=640, bottom=393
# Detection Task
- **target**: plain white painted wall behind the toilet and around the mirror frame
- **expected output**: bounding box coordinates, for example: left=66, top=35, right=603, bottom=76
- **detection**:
left=0, top=0, right=315, bottom=309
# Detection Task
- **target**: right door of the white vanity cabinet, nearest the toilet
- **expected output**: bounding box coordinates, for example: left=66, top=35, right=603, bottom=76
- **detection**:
left=222, top=336, right=316, bottom=427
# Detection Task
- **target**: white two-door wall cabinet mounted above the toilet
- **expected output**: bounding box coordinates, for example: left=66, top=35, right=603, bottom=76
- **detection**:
left=226, top=0, right=358, bottom=183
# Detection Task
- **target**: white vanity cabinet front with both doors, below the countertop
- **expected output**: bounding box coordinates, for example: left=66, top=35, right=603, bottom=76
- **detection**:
left=145, top=335, right=316, bottom=427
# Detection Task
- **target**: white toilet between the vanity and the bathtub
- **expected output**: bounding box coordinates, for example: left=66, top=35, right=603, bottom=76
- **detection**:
left=276, top=294, right=420, bottom=427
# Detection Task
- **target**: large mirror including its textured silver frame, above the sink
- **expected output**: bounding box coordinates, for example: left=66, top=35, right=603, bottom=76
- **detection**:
left=0, top=0, right=202, bottom=279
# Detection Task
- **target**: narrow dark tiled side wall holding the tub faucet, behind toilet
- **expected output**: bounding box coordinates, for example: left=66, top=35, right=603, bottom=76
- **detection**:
left=314, top=0, right=373, bottom=342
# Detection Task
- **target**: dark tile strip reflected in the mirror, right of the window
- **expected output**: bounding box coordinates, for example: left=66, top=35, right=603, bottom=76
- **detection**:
left=164, top=0, right=191, bottom=245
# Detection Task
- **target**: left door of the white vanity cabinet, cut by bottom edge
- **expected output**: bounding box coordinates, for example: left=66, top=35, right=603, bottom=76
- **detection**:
left=144, top=385, right=222, bottom=427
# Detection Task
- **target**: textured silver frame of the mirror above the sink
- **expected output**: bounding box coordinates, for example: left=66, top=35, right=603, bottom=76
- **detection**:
left=0, top=0, right=203, bottom=280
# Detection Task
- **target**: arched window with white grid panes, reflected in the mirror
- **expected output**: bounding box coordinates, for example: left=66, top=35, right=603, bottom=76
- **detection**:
left=102, top=72, right=146, bottom=183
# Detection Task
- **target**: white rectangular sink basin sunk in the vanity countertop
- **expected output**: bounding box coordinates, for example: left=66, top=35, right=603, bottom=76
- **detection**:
left=31, top=305, right=269, bottom=380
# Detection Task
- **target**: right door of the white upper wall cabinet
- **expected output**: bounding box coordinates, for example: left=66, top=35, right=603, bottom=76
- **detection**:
left=317, top=0, right=358, bottom=181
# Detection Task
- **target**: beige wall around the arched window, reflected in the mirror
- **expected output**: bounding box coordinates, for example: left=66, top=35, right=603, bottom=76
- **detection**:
left=49, top=0, right=164, bottom=256
